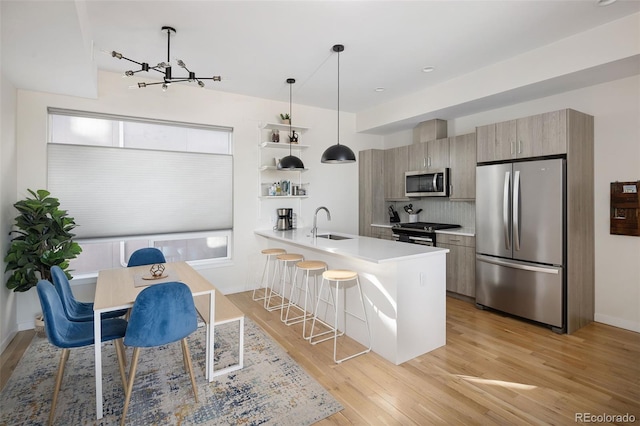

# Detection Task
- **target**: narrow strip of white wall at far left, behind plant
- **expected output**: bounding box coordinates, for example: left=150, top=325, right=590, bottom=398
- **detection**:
left=0, top=74, right=17, bottom=352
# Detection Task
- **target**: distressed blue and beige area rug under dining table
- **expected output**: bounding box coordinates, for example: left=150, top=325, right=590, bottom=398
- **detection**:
left=0, top=318, right=342, bottom=426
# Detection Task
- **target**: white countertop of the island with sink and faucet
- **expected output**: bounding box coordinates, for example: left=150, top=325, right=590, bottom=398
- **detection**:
left=254, top=228, right=449, bottom=263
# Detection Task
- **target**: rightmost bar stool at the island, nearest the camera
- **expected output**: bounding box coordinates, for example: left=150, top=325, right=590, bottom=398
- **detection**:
left=308, top=269, right=371, bottom=364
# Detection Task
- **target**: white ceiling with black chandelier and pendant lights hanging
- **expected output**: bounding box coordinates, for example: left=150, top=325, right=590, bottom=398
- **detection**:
left=1, top=0, right=640, bottom=126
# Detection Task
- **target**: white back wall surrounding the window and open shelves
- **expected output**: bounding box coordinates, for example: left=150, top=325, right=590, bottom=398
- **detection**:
left=11, top=72, right=382, bottom=329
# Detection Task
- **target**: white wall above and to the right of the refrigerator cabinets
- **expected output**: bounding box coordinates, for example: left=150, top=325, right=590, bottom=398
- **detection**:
left=385, top=75, right=640, bottom=332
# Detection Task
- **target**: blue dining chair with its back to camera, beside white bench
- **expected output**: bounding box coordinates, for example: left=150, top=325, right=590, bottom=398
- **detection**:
left=120, top=282, right=198, bottom=425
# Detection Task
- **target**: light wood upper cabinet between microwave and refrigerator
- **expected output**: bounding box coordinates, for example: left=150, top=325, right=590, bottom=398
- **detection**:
left=449, top=133, right=476, bottom=200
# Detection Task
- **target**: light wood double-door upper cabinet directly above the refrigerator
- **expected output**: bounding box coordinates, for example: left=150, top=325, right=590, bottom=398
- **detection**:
left=476, top=110, right=567, bottom=163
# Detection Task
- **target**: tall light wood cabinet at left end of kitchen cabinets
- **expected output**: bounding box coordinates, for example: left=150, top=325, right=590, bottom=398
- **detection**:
left=358, top=149, right=389, bottom=237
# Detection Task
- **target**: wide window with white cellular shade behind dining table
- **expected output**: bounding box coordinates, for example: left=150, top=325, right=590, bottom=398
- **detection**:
left=47, top=109, right=233, bottom=275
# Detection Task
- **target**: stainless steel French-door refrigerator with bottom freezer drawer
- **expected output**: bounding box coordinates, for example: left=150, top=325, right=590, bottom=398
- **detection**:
left=476, top=159, right=566, bottom=332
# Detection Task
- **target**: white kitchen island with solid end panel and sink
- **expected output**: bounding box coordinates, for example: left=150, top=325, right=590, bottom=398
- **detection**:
left=255, top=228, right=449, bottom=365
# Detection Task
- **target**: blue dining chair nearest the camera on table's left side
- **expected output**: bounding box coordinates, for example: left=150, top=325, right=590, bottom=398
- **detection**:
left=37, top=280, right=127, bottom=425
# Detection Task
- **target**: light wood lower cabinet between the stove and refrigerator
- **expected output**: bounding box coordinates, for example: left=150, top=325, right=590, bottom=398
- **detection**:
left=436, top=233, right=476, bottom=298
